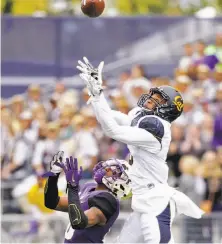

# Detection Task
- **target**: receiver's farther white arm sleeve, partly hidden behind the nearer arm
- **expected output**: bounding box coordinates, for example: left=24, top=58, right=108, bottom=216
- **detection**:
left=100, top=93, right=130, bottom=125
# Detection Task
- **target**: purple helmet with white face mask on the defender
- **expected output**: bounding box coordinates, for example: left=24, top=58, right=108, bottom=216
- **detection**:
left=93, top=158, right=131, bottom=198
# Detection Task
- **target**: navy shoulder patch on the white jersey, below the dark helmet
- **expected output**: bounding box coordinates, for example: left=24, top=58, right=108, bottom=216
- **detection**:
left=138, top=116, right=164, bottom=143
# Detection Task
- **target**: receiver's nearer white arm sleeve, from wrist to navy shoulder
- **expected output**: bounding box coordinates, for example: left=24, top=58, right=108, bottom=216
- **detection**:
left=92, top=97, right=161, bottom=153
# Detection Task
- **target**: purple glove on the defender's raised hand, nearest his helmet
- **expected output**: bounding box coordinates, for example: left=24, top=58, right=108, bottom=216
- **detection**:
left=58, top=156, right=83, bottom=187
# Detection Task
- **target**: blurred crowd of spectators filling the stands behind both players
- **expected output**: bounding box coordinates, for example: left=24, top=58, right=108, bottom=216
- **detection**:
left=1, top=33, right=222, bottom=217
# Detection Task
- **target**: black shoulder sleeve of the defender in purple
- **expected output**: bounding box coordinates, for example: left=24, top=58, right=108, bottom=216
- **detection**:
left=88, top=192, right=118, bottom=221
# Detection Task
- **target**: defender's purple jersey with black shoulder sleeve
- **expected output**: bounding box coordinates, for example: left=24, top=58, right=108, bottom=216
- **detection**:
left=65, top=183, right=119, bottom=243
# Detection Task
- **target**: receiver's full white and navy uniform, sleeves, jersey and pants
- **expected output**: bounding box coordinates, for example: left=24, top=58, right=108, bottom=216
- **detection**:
left=92, top=94, right=203, bottom=243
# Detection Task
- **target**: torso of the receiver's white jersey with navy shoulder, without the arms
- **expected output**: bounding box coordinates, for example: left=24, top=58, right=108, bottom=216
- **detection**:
left=128, top=109, right=171, bottom=193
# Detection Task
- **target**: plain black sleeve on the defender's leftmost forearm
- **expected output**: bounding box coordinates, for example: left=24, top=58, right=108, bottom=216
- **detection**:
left=44, top=174, right=59, bottom=209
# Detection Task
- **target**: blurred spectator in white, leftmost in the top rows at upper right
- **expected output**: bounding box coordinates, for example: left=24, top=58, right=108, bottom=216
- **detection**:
left=178, top=43, right=194, bottom=71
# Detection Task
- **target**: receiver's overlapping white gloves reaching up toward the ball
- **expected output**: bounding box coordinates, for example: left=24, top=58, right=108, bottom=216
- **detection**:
left=76, top=57, right=104, bottom=102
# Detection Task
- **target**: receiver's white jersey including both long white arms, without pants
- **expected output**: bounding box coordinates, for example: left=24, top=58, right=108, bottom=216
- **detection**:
left=92, top=95, right=171, bottom=194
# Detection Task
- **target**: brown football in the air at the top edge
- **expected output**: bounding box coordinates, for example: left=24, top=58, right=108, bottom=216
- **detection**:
left=81, top=0, right=105, bottom=18
